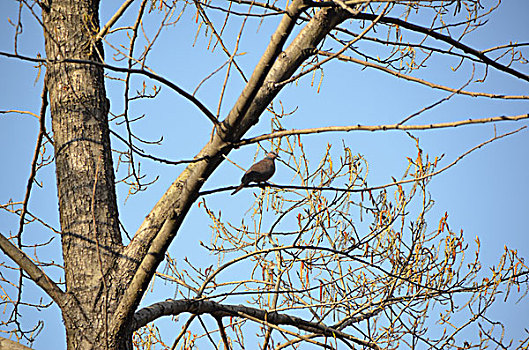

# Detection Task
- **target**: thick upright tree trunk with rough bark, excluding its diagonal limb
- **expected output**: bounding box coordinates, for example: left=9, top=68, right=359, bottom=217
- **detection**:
left=42, top=0, right=122, bottom=349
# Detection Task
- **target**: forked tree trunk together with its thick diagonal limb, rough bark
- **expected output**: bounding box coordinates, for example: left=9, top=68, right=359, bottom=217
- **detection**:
left=39, top=0, right=345, bottom=349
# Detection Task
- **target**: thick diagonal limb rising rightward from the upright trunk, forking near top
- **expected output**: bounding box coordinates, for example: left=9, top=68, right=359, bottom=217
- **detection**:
left=110, top=0, right=346, bottom=338
